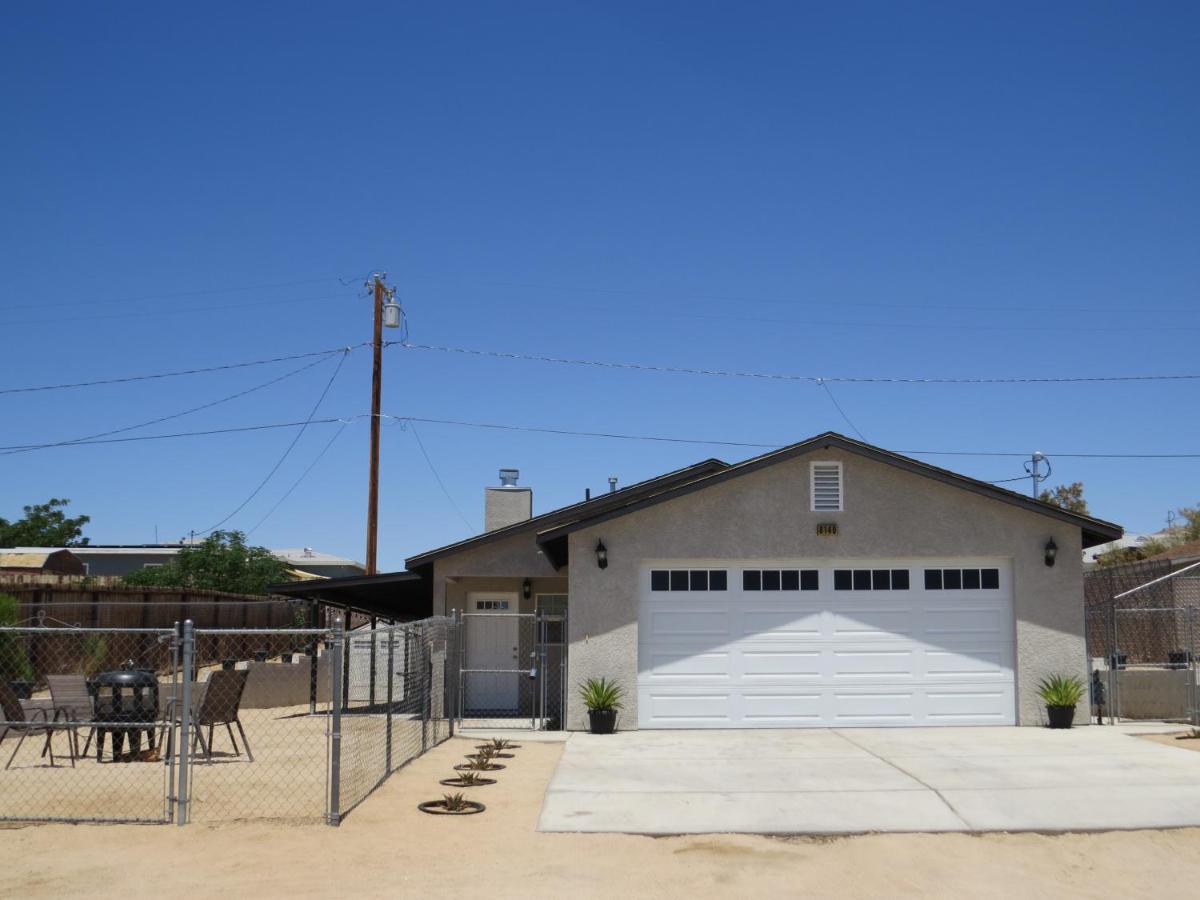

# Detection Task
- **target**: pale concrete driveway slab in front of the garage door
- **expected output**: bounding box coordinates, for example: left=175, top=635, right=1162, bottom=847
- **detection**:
left=538, top=727, right=1200, bottom=834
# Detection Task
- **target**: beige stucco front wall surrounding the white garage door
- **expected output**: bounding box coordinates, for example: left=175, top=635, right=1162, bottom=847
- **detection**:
left=561, top=450, right=1087, bottom=728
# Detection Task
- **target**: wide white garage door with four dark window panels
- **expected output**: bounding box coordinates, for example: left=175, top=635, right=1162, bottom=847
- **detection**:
left=637, top=559, right=1015, bottom=728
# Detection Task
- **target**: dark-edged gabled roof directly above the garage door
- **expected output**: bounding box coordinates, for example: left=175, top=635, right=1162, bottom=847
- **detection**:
left=538, top=431, right=1123, bottom=547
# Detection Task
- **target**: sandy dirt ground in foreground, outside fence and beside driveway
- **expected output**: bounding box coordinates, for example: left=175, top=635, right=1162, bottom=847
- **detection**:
left=0, top=739, right=1200, bottom=900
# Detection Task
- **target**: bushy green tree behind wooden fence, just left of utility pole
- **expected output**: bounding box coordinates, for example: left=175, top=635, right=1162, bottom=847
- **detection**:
left=125, top=532, right=288, bottom=594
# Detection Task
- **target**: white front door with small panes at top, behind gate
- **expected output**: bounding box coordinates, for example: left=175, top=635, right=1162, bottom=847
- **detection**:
left=464, top=592, right=521, bottom=715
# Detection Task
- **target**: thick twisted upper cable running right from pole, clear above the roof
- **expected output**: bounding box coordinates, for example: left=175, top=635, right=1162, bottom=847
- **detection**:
left=388, top=341, right=1200, bottom=384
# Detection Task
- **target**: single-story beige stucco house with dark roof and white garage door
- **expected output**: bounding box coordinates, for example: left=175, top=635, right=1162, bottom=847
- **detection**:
left=407, top=432, right=1122, bottom=728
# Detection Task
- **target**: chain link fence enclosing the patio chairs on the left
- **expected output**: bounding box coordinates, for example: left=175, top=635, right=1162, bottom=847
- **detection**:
left=0, top=617, right=457, bottom=824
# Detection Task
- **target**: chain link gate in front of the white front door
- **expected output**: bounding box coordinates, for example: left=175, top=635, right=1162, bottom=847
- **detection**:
left=455, top=611, right=566, bottom=731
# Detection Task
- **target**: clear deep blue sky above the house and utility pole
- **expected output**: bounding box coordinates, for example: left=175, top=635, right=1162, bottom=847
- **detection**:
left=0, top=2, right=1200, bottom=568
